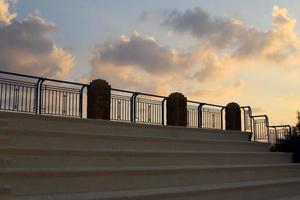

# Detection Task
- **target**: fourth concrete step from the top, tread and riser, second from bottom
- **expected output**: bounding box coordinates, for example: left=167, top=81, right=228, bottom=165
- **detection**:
left=0, top=164, right=300, bottom=195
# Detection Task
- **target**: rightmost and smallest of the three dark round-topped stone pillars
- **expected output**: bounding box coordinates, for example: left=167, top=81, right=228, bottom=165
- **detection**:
left=225, top=102, right=242, bottom=131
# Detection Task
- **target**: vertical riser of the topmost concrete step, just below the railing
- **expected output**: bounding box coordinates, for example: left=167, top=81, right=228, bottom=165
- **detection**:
left=0, top=113, right=248, bottom=141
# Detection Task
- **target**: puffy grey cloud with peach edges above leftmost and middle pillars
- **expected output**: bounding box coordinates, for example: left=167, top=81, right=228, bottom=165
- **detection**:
left=93, top=32, right=189, bottom=74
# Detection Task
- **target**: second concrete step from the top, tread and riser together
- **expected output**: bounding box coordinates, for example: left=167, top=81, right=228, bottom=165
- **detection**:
left=0, top=128, right=268, bottom=152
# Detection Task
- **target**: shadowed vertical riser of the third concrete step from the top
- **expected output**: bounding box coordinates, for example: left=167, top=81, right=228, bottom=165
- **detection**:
left=0, top=153, right=292, bottom=168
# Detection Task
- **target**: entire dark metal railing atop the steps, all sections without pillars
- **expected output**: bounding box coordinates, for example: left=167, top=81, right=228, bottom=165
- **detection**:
left=0, top=71, right=291, bottom=142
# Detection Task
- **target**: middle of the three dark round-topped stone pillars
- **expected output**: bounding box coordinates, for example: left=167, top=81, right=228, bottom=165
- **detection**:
left=167, top=92, right=187, bottom=126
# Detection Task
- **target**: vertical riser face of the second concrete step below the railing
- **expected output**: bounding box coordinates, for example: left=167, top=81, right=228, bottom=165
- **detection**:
left=0, top=133, right=268, bottom=152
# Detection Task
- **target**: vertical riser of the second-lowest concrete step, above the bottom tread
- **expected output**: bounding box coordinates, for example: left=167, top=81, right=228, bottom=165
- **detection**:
left=0, top=167, right=300, bottom=195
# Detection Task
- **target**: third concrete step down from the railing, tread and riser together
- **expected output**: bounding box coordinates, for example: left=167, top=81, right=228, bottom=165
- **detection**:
left=0, top=147, right=292, bottom=168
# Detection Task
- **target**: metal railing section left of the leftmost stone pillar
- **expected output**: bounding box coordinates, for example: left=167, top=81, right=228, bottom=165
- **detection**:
left=0, top=71, right=88, bottom=117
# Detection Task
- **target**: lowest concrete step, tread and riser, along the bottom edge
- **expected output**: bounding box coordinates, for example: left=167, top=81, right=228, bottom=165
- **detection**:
left=6, top=178, right=300, bottom=200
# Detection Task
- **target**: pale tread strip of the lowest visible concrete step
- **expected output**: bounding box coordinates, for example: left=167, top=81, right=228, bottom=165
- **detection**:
left=8, top=177, right=300, bottom=200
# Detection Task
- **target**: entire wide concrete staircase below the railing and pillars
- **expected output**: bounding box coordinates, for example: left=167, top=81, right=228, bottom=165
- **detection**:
left=0, top=112, right=300, bottom=200
